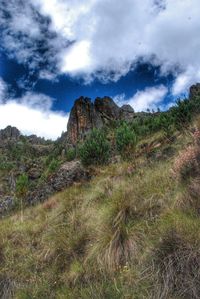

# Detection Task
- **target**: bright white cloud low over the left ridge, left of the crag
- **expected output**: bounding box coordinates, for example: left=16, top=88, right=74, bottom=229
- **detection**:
left=0, top=79, right=68, bottom=140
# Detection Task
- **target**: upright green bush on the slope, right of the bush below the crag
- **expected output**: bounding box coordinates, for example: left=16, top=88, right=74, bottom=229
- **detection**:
left=116, top=123, right=137, bottom=160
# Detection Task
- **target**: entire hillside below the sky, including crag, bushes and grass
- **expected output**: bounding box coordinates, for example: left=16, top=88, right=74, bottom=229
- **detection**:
left=0, top=85, right=200, bottom=299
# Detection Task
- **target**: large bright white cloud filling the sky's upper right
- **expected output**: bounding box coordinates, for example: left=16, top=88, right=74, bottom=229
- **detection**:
left=30, top=0, right=200, bottom=92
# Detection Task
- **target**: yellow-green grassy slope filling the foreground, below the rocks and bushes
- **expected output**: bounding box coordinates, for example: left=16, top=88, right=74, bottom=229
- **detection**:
left=0, top=114, right=200, bottom=299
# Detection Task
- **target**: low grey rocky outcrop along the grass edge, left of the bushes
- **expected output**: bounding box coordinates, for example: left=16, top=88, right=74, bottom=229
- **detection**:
left=26, top=161, right=89, bottom=204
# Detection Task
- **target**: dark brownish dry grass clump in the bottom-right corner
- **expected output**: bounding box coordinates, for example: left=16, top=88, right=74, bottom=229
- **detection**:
left=154, top=231, right=200, bottom=299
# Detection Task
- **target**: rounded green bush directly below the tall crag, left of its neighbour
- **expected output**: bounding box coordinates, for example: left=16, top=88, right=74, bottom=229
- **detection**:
left=79, top=129, right=110, bottom=166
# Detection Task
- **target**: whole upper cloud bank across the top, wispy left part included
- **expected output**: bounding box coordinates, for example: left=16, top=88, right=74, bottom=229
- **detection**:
left=0, top=0, right=200, bottom=94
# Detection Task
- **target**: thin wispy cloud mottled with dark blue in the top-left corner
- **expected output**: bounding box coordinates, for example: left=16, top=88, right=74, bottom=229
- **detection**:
left=0, top=0, right=68, bottom=80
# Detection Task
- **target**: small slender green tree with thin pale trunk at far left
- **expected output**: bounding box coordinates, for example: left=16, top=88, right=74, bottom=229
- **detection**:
left=16, top=174, right=29, bottom=221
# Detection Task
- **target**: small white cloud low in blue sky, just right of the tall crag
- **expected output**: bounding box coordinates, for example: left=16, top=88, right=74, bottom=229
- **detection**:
left=114, top=85, right=168, bottom=112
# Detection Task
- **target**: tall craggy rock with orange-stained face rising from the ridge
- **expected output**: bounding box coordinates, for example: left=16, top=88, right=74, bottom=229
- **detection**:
left=67, top=97, right=134, bottom=145
